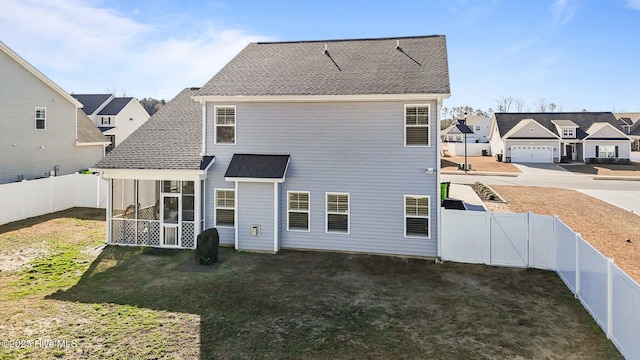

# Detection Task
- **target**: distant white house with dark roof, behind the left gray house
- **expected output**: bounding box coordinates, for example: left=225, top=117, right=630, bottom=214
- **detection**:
left=71, top=94, right=149, bottom=152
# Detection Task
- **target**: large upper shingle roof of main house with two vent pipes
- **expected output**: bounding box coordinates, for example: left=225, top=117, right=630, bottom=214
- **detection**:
left=198, top=35, right=450, bottom=96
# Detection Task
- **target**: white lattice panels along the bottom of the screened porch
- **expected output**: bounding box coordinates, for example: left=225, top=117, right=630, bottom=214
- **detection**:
left=109, top=218, right=195, bottom=249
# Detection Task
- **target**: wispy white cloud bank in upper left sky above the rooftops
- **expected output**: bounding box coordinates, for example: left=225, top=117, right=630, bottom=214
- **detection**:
left=0, top=0, right=267, bottom=100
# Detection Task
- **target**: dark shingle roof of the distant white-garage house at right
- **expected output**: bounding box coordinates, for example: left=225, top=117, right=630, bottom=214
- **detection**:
left=495, top=111, right=622, bottom=139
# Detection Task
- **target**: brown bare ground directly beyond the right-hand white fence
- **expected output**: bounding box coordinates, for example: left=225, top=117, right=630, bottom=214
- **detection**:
left=487, top=185, right=640, bottom=283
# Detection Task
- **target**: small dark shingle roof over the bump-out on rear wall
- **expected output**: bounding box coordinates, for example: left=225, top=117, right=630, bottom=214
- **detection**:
left=224, top=154, right=289, bottom=180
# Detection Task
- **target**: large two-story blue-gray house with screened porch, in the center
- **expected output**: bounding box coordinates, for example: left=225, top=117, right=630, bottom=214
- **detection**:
left=94, top=36, right=450, bottom=256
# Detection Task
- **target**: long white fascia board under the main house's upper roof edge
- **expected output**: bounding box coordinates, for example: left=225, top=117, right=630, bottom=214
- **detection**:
left=192, top=94, right=451, bottom=104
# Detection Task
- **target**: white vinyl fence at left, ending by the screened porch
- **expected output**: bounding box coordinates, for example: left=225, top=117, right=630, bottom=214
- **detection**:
left=0, top=174, right=108, bottom=224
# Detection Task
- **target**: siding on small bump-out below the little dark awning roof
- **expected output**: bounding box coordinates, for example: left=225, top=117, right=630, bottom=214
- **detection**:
left=237, top=182, right=274, bottom=251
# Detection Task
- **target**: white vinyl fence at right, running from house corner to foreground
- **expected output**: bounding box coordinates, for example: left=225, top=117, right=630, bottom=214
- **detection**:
left=441, top=209, right=640, bottom=359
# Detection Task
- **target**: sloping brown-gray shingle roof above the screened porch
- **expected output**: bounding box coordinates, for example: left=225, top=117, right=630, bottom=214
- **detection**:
left=94, top=88, right=202, bottom=170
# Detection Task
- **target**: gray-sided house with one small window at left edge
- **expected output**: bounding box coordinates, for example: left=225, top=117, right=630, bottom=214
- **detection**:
left=0, top=42, right=108, bottom=184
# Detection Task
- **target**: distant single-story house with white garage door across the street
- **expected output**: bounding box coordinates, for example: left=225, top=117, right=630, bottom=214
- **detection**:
left=491, top=112, right=631, bottom=163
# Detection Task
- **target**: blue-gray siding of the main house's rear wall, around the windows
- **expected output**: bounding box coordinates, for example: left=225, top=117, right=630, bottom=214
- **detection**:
left=207, top=101, right=439, bottom=256
